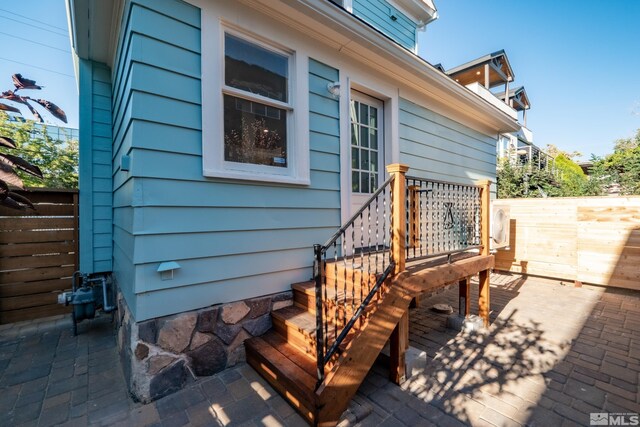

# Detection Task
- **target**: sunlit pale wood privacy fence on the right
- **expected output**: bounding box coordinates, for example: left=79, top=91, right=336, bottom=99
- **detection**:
left=494, top=197, right=640, bottom=290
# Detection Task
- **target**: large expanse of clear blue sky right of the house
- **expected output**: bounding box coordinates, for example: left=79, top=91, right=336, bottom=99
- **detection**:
left=419, top=0, right=640, bottom=159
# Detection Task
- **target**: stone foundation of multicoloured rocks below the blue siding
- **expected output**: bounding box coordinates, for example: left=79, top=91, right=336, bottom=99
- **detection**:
left=118, top=291, right=293, bottom=403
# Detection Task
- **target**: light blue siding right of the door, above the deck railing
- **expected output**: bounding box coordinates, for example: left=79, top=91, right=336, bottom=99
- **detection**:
left=399, top=99, right=496, bottom=184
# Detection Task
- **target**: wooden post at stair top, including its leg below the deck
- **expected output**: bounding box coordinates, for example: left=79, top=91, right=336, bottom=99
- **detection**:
left=387, top=163, right=409, bottom=384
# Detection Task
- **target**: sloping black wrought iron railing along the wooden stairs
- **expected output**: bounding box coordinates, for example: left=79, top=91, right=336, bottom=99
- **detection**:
left=314, top=177, right=395, bottom=386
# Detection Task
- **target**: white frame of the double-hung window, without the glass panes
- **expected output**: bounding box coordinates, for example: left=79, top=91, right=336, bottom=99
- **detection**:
left=202, top=19, right=310, bottom=185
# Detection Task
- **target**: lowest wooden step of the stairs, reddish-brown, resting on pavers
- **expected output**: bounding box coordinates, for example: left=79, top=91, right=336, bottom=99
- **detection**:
left=244, top=331, right=317, bottom=424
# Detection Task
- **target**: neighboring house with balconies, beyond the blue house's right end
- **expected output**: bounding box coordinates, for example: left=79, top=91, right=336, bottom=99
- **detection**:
left=437, top=50, right=553, bottom=169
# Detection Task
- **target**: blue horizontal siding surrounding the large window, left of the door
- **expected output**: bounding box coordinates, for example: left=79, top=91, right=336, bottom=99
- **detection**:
left=110, top=0, right=340, bottom=321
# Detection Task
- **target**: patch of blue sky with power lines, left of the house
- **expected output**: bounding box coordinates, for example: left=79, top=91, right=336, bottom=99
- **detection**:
left=0, top=0, right=78, bottom=128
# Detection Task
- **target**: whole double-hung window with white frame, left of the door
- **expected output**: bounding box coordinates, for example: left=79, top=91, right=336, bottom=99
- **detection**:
left=202, top=20, right=310, bottom=185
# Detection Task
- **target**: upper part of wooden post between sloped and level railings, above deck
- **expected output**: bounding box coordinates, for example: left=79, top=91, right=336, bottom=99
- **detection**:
left=387, top=163, right=409, bottom=274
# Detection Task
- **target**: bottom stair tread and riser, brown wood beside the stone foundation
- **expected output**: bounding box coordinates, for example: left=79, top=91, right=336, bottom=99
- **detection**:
left=245, top=336, right=316, bottom=422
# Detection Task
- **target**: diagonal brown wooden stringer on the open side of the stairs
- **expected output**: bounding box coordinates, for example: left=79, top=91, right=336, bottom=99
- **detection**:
left=315, top=283, right=413, bottom=426
